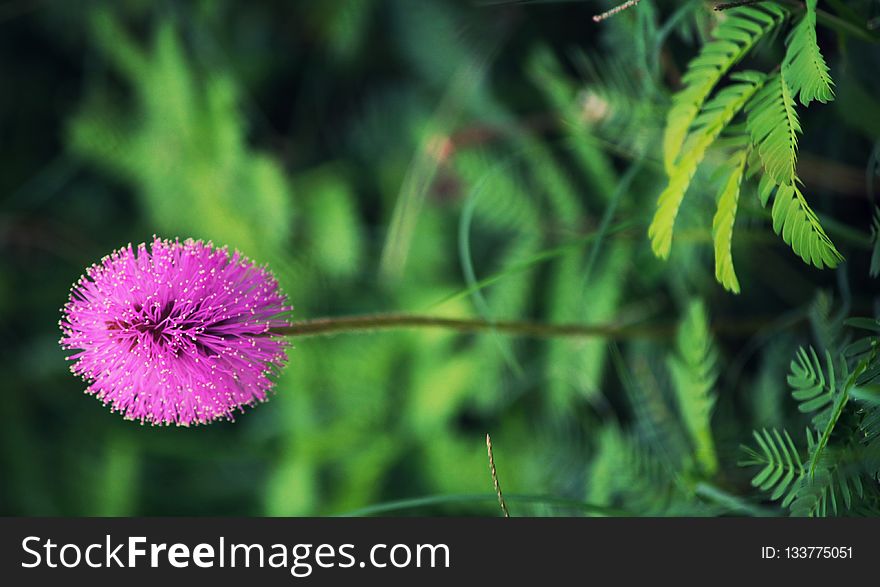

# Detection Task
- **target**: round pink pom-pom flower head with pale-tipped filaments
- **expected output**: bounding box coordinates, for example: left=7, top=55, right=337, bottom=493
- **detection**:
left=60, top=238, right=292, bottom=426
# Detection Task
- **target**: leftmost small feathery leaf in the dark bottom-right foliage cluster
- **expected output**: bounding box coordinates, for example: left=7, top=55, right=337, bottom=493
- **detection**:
left=740, top=428, right=806, bottom=507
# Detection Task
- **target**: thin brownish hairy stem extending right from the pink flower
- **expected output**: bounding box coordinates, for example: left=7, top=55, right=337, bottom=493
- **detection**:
left=271, top=314, right=674, bottom=339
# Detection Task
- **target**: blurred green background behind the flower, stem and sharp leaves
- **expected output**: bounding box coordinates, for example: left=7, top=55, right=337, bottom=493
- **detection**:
left=0, top=0, right=880, bottom=516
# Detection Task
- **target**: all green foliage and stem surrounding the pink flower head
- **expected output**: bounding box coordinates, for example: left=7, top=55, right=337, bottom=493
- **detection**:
left=0, top=0, right=880, bottom=516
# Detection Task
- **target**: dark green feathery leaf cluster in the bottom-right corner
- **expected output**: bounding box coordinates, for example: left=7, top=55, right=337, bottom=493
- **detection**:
left=740, top=319, right=880, bottom=516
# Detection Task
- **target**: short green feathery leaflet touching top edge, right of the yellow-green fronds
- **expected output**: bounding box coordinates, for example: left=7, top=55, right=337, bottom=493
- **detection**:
left=782, top=0, right=834, bottom=106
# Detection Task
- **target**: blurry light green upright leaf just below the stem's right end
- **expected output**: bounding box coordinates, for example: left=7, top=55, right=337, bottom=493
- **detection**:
left=668, top=301, right=718, bottom=475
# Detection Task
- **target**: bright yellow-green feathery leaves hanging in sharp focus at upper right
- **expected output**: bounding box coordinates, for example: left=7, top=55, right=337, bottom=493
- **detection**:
left=648, top=0, right=843, bottom=293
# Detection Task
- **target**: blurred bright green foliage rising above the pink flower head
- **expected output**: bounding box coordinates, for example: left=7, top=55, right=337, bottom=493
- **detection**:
left=68, top=12, right=292, bottom=261
